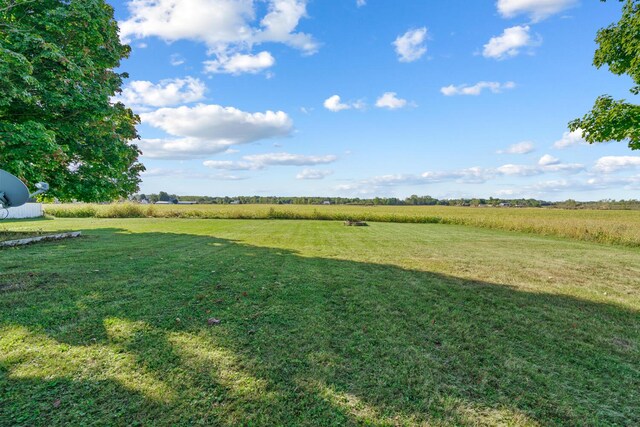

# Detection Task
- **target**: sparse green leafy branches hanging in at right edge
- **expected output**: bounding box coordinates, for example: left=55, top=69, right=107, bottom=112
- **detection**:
left=569, top=0, right=640, bottom=150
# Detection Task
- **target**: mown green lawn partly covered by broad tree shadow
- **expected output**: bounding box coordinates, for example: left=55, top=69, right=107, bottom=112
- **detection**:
left=0, top=218, right=640, bottom=426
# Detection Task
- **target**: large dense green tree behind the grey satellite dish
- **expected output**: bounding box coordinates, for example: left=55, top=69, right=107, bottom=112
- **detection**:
left=0, top=0, right=144, bottom=201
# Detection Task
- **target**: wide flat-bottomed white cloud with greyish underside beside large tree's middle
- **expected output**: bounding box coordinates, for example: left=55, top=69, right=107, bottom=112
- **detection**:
left=138, top=104, right=293, bottom=159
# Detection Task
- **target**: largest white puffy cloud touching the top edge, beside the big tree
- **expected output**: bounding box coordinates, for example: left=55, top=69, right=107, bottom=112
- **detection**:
left=118, top=0, right=319, bottom=74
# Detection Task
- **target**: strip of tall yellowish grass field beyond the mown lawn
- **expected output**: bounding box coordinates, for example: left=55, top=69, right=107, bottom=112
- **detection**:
left=45, top=203, right=640, bottom=247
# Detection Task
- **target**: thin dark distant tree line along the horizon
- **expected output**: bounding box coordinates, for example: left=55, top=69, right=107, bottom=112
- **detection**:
left=132, top=191, right=640, bottom=209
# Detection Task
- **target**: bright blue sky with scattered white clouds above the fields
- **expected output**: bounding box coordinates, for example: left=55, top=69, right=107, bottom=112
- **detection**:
left=109, top=0, right=640, bottom=200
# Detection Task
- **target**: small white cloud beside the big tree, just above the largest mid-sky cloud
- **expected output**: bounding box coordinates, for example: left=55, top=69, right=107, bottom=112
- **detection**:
left=115, top=77, right=206, bottom=108
